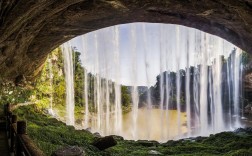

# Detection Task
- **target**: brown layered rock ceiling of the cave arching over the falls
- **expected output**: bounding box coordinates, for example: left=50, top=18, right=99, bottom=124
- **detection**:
left=0, top=0, right=252, bottom=80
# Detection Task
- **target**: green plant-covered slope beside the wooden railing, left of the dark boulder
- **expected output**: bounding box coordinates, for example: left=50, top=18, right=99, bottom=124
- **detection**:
left=14, top=106, right=102, bottom=155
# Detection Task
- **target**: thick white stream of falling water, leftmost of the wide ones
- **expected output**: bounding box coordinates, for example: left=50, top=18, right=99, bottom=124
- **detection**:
left=61, top=42, right=75, bottom=125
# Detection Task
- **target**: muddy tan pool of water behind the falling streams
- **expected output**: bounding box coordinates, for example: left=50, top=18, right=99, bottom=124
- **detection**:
left=83, top=108, right=187, bottom=142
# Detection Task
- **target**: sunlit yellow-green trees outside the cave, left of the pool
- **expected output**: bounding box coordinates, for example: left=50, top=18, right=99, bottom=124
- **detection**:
left=27, top=48, right=134, bottom=119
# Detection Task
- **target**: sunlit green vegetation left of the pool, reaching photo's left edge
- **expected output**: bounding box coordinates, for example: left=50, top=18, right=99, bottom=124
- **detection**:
left=0, top=45, right=134, bottom=124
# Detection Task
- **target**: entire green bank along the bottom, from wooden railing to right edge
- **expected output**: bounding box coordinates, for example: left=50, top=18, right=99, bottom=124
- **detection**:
left=14, top=106, right=252, bottom=156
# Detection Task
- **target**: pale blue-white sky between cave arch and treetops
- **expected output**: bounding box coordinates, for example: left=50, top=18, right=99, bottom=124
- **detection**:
left=70, top=23, right=235, bottom=86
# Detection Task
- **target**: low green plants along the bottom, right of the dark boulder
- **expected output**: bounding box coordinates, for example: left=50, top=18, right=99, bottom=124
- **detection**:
left=107, top=132, right=252, bottom=156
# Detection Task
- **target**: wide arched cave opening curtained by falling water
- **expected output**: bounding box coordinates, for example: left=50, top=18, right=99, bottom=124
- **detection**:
left=45, top=23, right=245, bottom=142
